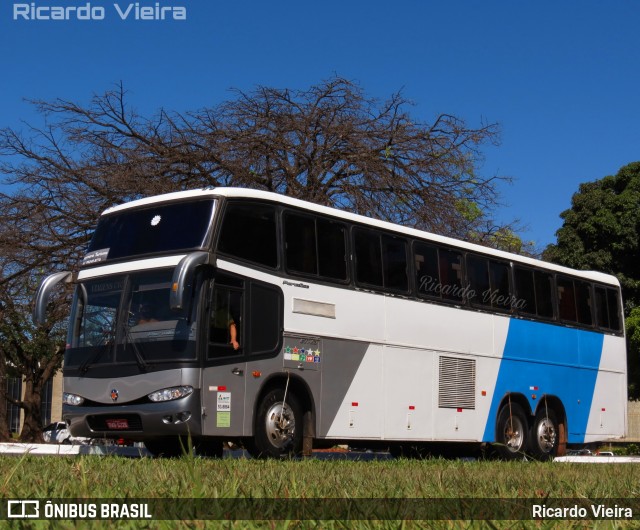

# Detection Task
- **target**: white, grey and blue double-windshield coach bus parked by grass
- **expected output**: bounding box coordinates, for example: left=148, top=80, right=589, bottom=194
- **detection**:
left=34, top=188, right=627, bottom=458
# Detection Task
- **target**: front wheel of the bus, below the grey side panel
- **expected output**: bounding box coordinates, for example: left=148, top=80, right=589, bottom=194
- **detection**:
left=252, top=388, right=302, bottom=458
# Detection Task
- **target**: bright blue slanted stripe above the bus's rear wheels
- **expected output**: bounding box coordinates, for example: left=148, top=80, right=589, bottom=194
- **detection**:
left=483, top=319, right=604, bottom=443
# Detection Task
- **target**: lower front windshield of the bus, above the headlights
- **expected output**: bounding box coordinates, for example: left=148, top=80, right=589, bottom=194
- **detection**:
left=65, top=270, right=196, bottom=372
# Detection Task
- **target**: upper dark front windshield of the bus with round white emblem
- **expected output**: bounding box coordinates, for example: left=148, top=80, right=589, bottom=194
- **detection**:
left=83, top=199, right=215, bottom=265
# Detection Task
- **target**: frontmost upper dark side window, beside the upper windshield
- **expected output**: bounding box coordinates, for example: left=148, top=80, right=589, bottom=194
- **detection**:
left=218, top=202, right=278, bottom=268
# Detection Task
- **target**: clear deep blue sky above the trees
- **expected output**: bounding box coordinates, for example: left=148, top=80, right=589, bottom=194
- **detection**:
left=0, top=0, right=640, bottom=248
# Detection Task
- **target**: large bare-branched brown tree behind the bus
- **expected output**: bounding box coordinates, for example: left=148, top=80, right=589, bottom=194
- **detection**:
left=0, top=78, right=505, bottom=436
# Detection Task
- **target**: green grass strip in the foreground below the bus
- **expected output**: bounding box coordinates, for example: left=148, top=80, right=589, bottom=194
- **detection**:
left=0, top=456, right=640, bottom=528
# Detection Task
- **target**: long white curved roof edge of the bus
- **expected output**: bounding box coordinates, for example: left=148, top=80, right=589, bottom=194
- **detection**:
left=102, top=188, right=620, bottom=286
